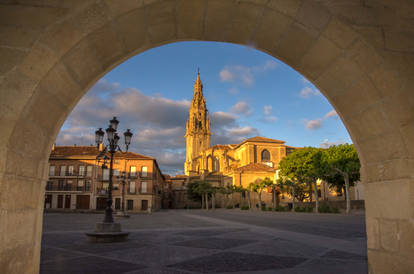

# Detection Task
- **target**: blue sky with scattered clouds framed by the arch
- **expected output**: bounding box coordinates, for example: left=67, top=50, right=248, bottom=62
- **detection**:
left=57, top=42, right=351, bottom=174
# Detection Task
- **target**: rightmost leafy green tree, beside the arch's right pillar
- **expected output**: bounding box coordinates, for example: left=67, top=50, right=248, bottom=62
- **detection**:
left=322, top=144, right=361, bottom=214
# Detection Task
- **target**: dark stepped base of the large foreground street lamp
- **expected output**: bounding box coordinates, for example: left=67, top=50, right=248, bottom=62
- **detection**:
left=86, top=223, right=129, bottom=243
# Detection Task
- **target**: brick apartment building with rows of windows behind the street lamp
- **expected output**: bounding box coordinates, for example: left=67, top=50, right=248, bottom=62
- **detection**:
left=45, top=146, right=165, bottom=212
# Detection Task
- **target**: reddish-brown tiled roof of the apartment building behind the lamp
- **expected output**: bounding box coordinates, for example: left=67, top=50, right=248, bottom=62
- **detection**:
left=50, top=146, right=154, bottom=160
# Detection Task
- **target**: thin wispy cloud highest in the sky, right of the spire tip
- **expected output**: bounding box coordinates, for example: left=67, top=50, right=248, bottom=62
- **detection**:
left=219, top=60, right=277, bottom=87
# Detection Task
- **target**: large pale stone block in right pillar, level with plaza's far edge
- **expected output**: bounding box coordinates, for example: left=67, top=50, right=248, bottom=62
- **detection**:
left=364, top=179, right=413, bottom=220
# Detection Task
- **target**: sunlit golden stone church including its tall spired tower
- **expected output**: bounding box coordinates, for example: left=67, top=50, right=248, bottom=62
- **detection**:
left=184, top=73, right=297, bottom=187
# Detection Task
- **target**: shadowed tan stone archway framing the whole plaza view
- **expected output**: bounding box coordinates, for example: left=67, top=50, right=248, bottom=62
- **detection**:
left=0, top=0, right=414, bottom=273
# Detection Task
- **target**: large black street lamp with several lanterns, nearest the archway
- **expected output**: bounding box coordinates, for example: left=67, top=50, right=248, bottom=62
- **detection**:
left=86, top=117, right=132, bottom=242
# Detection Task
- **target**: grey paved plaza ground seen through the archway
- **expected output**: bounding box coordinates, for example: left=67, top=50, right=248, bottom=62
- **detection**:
left=40, top=209, right=368, bottom=274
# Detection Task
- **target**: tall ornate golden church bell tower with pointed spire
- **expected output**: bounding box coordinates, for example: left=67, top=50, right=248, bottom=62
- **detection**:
left=184, top=71, right=211, bottom=175
